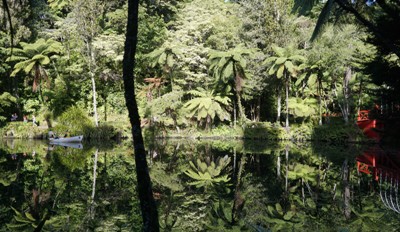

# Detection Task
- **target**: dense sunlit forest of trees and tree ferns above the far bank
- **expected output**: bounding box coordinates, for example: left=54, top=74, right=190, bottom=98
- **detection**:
left=0, top=0, right=399, bottom=140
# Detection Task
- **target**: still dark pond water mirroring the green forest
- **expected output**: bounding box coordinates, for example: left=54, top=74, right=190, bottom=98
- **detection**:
left=0, top=140, right=400, bottom=231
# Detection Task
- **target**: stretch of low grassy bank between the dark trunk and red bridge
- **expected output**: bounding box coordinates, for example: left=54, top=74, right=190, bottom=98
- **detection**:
left=144, top=122, right=373, bottom=143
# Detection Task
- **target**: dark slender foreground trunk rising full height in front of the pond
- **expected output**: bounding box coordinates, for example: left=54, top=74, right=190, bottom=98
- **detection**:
left=123, top=0, right=160, bottom=231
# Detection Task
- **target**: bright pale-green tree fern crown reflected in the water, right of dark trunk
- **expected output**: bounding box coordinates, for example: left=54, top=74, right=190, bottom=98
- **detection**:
left=184, top=155, right=231, bottom=189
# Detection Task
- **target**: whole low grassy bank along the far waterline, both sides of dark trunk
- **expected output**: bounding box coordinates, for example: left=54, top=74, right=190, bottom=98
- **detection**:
left=0, top=117, right=371, bottom=143
